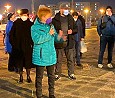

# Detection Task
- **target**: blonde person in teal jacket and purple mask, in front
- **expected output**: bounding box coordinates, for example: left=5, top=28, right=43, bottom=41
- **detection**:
left=31, top=7, right=63, bottom=98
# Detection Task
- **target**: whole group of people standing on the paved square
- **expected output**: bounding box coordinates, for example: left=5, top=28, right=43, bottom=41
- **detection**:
left=5, top=4, right=115, bottom=98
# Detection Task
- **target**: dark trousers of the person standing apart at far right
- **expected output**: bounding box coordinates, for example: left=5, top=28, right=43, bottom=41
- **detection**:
left=98, top=36, right=114, bottom=64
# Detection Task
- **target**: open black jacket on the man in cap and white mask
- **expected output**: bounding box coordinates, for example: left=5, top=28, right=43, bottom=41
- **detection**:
left=52, top=12, right=77, bottom=49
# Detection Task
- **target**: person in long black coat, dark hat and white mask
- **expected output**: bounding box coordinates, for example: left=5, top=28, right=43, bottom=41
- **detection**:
left=10, top=9, right=33, bottom=83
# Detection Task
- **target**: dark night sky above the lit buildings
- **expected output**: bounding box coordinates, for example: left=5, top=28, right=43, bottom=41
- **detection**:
left=0, top=0, right=115, bottom=10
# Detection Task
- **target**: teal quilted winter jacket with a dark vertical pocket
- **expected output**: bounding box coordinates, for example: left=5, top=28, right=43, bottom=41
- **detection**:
left=31, top=18, right=63, bottom=66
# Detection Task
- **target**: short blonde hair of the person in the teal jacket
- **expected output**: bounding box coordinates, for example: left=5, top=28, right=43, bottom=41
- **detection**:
left=37, top=7, right=52, bottom=20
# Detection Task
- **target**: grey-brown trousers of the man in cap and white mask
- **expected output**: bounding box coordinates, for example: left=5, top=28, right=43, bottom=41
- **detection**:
left=55, top=49, right=74, bottom=75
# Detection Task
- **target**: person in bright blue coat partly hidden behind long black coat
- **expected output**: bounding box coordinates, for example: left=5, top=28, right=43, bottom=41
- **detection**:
left=5, top=13, right=18, bottom=72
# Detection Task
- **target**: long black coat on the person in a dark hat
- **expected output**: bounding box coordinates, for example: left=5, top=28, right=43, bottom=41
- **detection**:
left=10, top=18, right=33, bottom=68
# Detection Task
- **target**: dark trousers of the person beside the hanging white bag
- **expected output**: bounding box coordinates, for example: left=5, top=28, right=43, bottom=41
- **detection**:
left=75, top=41, right=81, bottom=64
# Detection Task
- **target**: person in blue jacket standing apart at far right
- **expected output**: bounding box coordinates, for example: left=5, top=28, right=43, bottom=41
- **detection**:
left=97, top=6, right=115, bottom=68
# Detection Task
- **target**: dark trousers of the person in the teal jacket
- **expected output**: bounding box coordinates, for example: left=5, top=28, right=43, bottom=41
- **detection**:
left=35, top=65, right=55, bottom=98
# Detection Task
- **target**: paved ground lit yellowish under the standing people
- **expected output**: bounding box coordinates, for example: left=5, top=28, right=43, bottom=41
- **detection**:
left=0, top=28, right=115, bottom=98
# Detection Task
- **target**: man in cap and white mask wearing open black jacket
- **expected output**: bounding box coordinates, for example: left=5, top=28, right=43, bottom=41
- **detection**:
left=52, top=3, right=77, bottom=80
